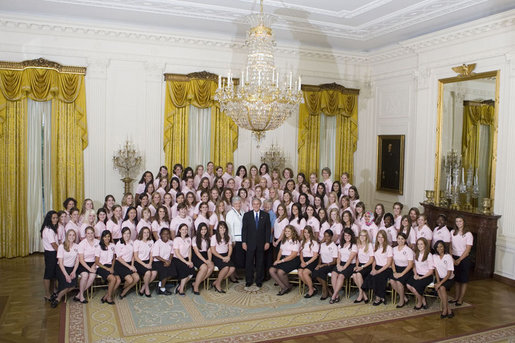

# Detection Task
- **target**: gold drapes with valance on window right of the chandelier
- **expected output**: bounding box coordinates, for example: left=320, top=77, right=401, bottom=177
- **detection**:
left=298, top=84, right=359, bottom=180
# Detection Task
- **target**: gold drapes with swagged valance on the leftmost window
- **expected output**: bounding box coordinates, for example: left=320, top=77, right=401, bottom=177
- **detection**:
left=0, top=64, right=88, bottom=257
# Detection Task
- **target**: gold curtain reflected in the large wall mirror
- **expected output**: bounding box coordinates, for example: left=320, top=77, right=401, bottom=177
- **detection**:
left=461, top=100, right=495, bottom=178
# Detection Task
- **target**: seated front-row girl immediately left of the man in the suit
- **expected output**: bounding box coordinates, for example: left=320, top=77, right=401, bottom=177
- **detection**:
left=211, top=222, right=235, bottom=293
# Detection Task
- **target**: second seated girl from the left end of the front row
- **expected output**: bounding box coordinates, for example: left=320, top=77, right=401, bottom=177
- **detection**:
left=73, top=226, right=99, bottom=304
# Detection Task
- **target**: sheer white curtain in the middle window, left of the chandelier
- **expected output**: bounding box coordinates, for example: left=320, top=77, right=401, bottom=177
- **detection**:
left=188, top=106, right=211, bottom=168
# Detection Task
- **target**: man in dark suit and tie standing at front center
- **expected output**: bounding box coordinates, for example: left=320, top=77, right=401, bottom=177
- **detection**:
left=241, top=199, right=271, bottom=287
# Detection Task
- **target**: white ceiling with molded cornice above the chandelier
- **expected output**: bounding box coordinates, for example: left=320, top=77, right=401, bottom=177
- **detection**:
left=0, top=0, right=515, bottom=52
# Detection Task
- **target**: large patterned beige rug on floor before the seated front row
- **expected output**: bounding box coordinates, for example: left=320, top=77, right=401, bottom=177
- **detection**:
left=63, top=282, right=470, bottom=343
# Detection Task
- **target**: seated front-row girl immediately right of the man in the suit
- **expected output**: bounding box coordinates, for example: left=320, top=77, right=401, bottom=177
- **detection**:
left=269, top=225, right=300, bottom=296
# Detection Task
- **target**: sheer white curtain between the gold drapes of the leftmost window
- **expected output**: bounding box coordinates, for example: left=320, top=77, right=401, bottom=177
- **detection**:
left=27, top=99, right=52, bottom=253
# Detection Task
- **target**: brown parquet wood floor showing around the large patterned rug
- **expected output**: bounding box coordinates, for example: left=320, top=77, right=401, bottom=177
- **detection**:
left=0, top=254, right=515, bottom=343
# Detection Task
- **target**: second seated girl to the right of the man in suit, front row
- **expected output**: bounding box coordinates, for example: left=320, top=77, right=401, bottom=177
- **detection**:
left=298, top=225, right=320, bottom=298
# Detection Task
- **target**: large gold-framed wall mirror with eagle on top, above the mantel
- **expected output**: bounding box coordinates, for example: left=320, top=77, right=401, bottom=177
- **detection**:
left=434, top=65, right=499, bottom=211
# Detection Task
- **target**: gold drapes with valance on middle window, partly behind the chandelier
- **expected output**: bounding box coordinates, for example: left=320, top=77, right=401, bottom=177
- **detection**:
left=163, top=72, right=238, bottom=169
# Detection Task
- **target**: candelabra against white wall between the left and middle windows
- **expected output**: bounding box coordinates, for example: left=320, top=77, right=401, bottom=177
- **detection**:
left=113, top=139, right=143, bottom=194
